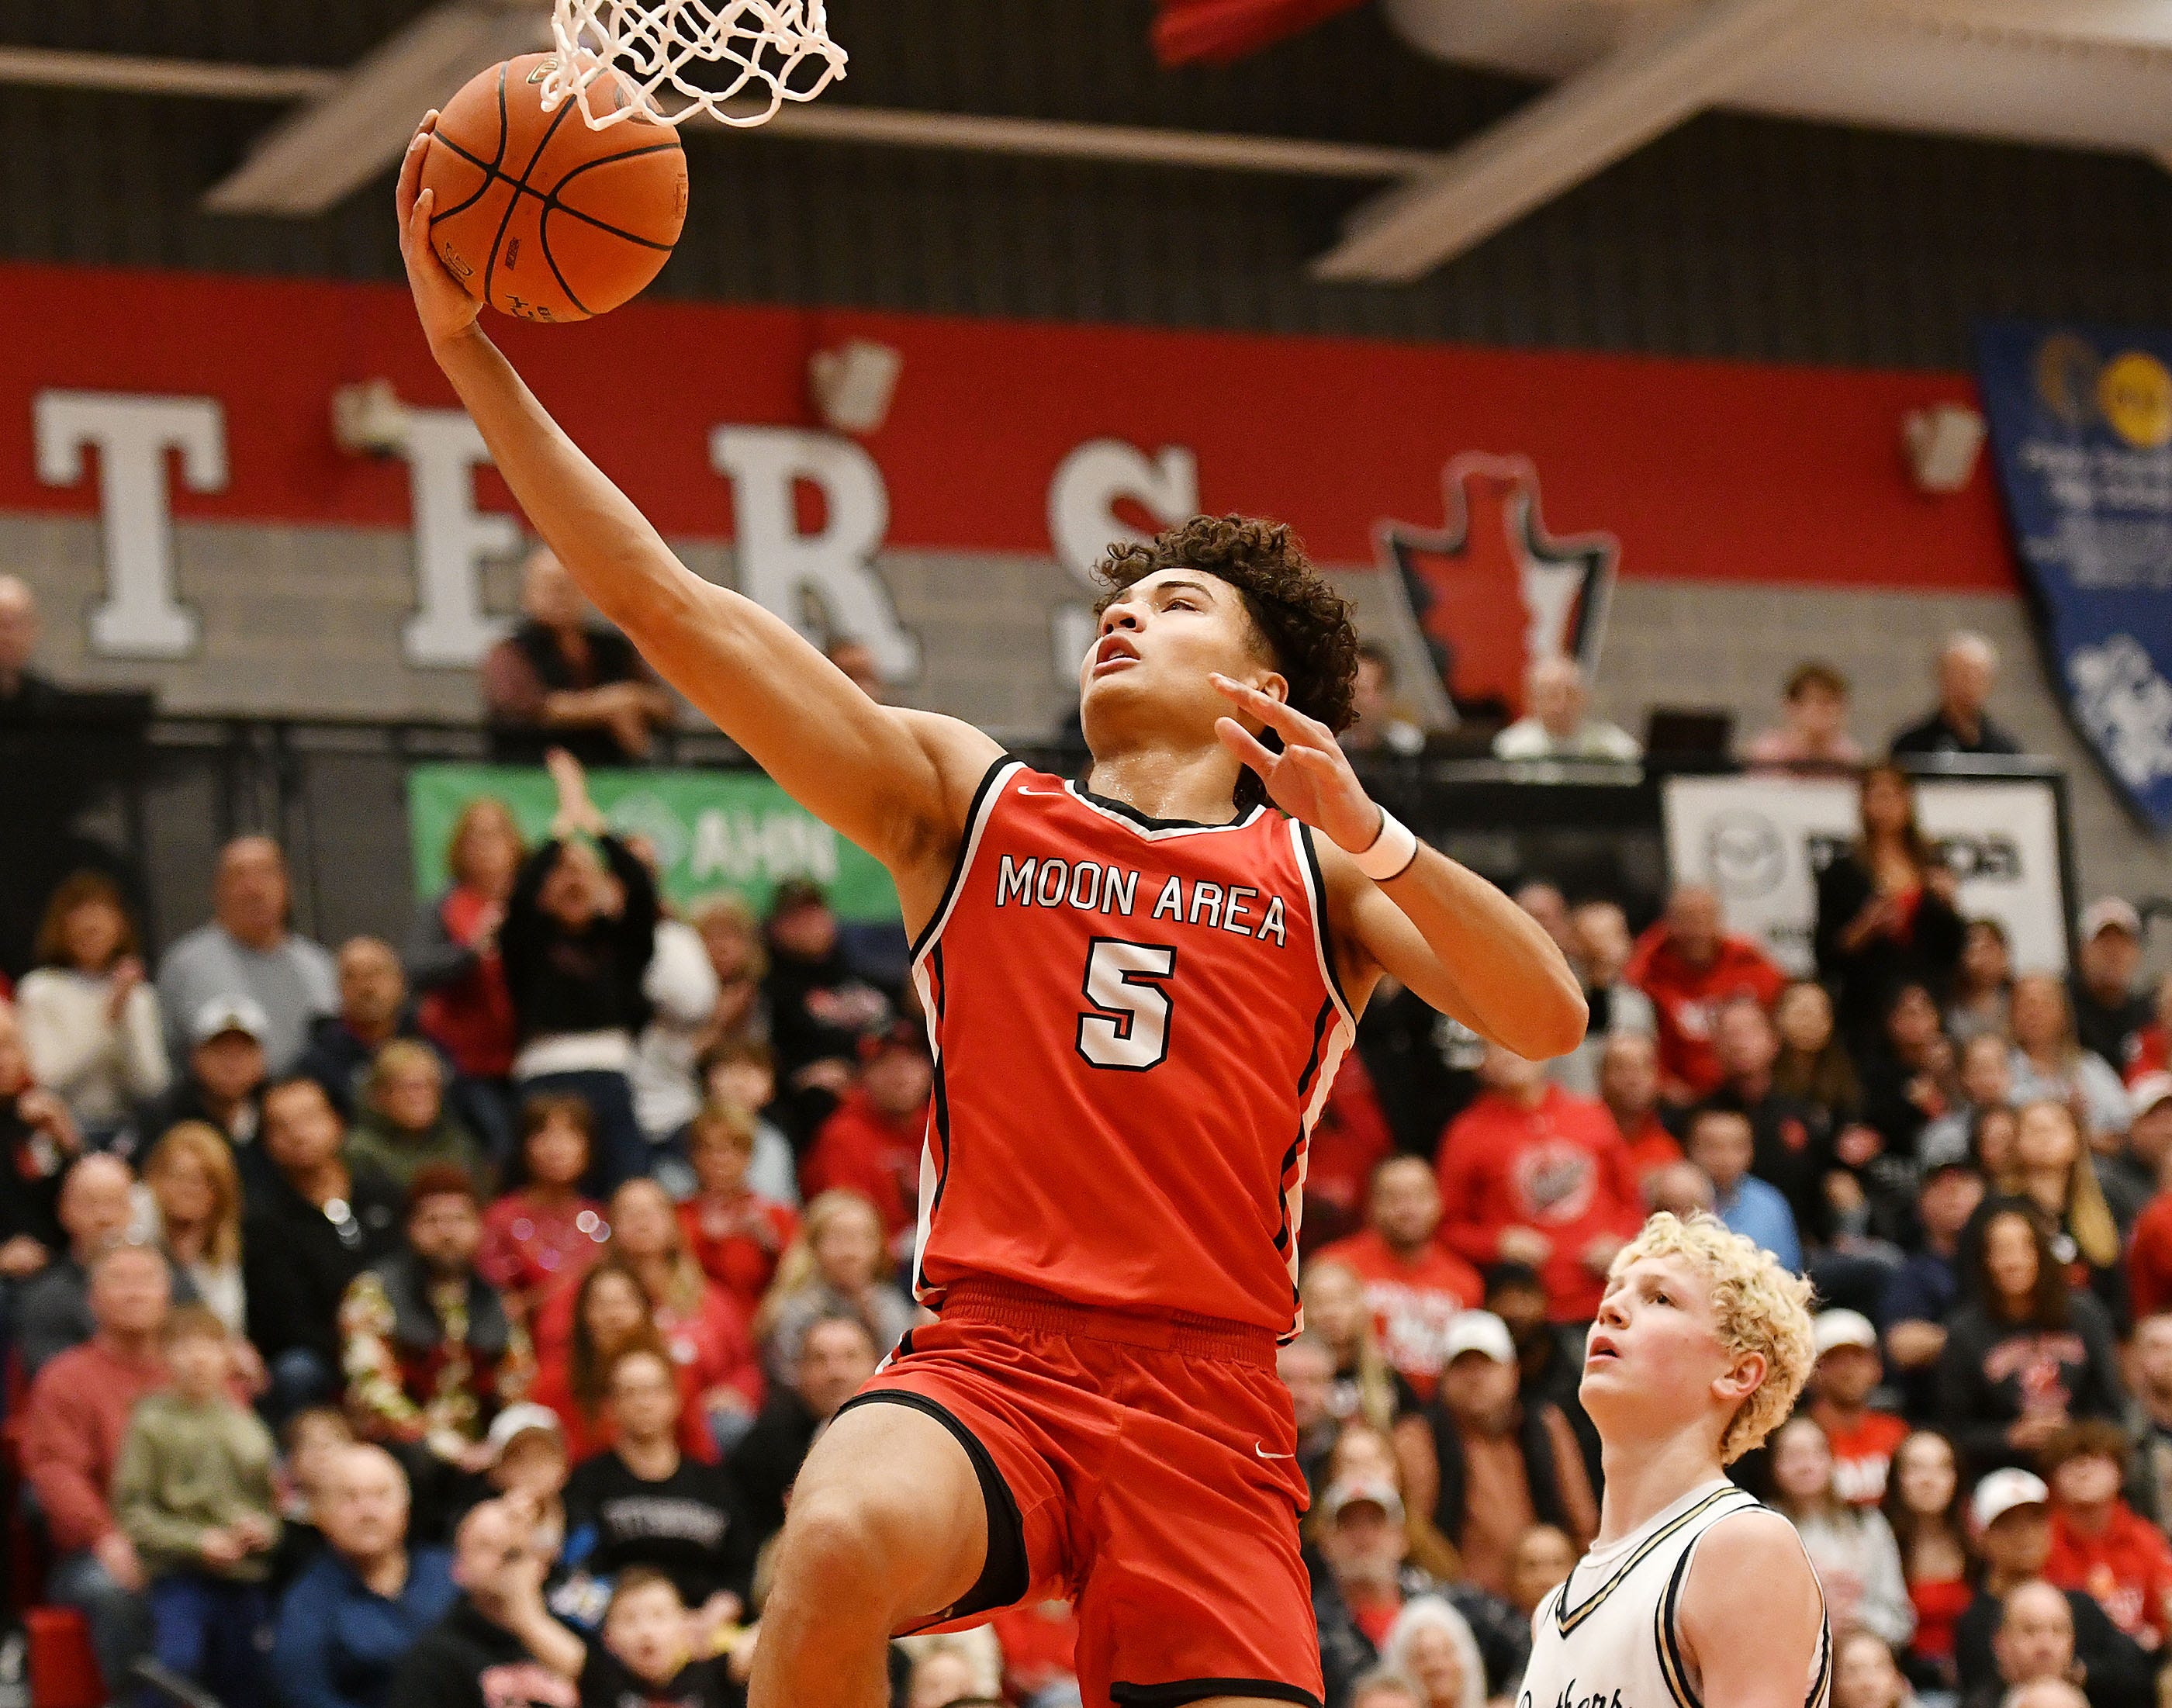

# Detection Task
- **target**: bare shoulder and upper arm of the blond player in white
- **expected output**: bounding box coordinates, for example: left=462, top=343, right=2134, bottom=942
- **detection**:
left=1677, top=1510, right=1831, bottom=1708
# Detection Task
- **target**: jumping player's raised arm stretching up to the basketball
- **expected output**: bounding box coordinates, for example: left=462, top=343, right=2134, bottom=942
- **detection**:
left=397, top=113, right=999, bottom=899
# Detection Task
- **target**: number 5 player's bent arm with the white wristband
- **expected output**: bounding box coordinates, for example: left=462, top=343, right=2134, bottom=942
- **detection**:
left=1214, top=676, right=1586, bottom=1060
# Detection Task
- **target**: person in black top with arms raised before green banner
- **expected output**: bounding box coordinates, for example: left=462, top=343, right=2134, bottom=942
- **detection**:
left=497, top=748, right=658, bottom=1198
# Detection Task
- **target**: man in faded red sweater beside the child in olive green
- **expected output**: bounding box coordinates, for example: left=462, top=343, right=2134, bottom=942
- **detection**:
left=16, top=1245, right=171, bottom=1702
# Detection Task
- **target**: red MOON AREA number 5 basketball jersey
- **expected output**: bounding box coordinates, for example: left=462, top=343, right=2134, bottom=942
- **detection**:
left=912, top=761, right=1355, bottom=1334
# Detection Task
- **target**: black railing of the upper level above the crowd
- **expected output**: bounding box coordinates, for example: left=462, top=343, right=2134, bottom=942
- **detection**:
left=0, top=715, right=2129, bottom=971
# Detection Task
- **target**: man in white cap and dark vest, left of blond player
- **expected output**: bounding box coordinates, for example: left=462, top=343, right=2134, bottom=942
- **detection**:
left=1423, top=1310, right=1599, bottom=1595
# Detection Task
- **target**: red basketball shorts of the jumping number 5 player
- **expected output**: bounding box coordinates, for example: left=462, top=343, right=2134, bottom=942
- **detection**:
left=849, top=1282, right=1320, bottom=1708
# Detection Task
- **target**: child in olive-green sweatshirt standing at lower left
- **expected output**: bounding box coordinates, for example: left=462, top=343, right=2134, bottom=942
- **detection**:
left=113, top=1304, right=280, bottom=1708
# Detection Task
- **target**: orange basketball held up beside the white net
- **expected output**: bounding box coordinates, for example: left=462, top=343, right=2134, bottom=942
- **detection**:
left=421, top=54, right=687, bottom=320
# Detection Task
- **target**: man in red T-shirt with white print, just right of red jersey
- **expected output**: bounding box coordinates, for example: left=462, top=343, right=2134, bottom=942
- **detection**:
left=1319, top=1156, right=1485, bottom=1399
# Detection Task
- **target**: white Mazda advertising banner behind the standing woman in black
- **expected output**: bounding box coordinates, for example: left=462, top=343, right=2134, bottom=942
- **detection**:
left=1664, top=776, right=2068, bottom=976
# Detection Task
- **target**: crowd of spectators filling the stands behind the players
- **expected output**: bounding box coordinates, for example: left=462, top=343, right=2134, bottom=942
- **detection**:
left=0, top=613, right=2172, bottom=1708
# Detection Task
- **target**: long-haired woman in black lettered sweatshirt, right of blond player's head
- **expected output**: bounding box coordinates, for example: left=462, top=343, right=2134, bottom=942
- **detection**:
left=1938, top=1198, right=2126, bottom=1473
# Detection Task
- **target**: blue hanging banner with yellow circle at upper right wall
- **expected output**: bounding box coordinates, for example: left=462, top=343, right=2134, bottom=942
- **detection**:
left=1977, top=322, right=2172, bottom=832
